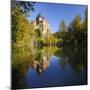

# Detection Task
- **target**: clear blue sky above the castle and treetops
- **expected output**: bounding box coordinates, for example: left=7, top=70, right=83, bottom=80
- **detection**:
left=29, top=2, right=86, bottom=33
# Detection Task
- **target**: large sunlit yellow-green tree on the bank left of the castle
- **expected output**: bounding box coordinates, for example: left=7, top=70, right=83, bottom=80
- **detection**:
left=11, top=1, right=35, bottom=49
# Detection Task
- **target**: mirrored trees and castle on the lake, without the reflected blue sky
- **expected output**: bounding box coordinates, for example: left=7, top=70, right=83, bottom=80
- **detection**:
left=12, top=47, right=87, bottom=88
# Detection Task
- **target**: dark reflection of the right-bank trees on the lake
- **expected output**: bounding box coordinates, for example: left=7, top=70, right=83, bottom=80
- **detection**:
left=55, top=47, right=87, bottom=72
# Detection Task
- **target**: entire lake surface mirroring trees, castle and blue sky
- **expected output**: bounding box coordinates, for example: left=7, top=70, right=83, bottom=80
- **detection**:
left=12, top=47, right=87, bottom=88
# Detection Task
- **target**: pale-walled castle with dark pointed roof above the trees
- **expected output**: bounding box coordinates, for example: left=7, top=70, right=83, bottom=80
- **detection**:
left=31, top=13, right=50, bottom=36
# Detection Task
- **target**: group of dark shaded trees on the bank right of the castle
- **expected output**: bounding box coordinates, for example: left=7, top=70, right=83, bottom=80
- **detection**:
left=53, top=9, right=87, bottom=47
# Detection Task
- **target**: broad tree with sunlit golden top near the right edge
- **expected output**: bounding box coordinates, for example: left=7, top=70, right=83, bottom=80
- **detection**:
left=68, top=13, right=87, bottom=46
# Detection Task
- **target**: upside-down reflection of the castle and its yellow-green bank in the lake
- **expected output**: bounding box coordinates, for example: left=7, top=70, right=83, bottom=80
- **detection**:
left=31, top=47, right=56, bottom=75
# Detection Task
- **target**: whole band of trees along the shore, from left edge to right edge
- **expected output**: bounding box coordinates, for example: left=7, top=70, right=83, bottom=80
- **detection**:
left=11, top=1, right=87, bottom=52
